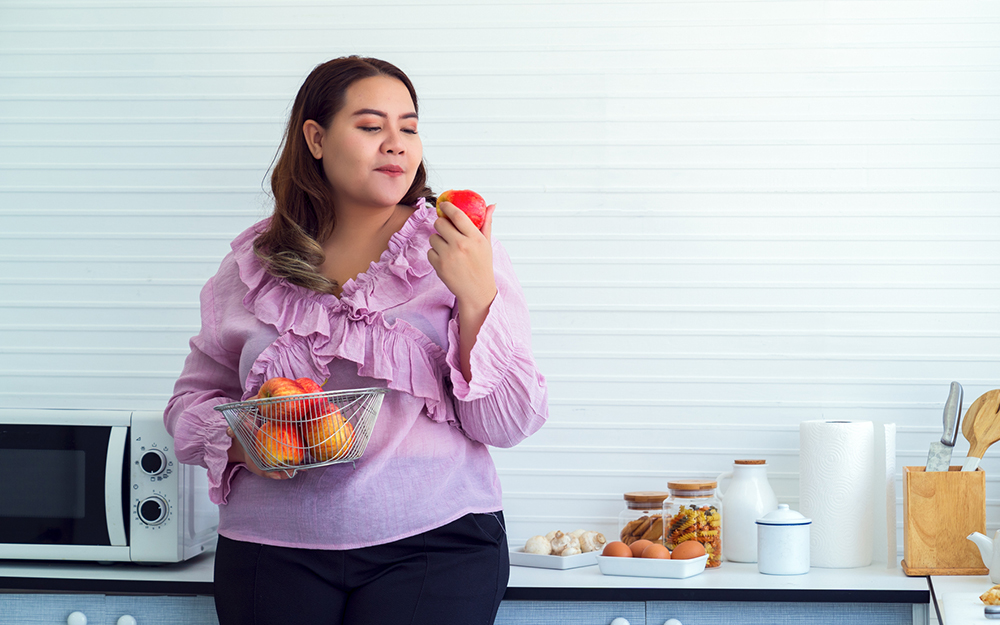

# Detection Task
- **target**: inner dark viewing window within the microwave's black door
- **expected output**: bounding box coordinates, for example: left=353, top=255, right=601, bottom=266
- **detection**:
left=0, top=449, right=87, bottom=519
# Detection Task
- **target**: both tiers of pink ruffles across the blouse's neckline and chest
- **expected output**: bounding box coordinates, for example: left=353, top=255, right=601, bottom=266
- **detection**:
left=232, top=200, right=455, bottom=422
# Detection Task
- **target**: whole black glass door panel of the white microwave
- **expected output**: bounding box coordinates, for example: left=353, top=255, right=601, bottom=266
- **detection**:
left=0, top=424, right=116, bottom=546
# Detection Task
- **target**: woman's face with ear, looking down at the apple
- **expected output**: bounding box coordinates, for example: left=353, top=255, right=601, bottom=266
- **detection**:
left=303, top=76, right=423, bottom=207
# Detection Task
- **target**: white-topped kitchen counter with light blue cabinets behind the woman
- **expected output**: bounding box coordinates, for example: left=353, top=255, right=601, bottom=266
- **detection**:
left=0, top=553, right=930, bottom=625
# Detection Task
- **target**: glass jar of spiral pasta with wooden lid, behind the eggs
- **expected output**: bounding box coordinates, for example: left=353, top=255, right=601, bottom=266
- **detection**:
left=663, top=480, right=722, bottom=567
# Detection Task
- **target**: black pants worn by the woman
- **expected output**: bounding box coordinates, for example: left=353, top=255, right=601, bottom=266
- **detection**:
left=215, top=512, right=510, bottom=625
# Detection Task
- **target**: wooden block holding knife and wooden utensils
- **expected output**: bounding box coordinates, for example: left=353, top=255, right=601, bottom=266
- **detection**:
left=901, top=466, right=989, bottom=575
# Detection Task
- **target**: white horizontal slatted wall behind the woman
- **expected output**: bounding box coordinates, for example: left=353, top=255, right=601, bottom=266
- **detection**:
left=0, top=0, right=1000, bottom=564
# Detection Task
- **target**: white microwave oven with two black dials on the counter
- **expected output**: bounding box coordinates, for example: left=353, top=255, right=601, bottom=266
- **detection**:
left=0, top=409, right=219, bottom=563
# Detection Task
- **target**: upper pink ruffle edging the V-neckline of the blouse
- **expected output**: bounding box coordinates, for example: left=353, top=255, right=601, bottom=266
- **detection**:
left=231, top=198, right=436, bottom=322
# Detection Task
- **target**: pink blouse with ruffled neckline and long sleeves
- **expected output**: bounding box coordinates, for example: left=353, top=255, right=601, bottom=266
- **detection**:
left=164, top=199, right=548, bottom=549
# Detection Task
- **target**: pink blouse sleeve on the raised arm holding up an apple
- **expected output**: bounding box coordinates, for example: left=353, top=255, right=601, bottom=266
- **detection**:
left=447, top=242, right=548, bottom=447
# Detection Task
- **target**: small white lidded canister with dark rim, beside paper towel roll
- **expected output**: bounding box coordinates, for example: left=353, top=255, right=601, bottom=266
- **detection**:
left=757, top=503, right=812, bottom=575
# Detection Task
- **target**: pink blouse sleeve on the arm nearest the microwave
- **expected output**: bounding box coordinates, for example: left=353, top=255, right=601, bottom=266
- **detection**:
left=163, top=262, right=242, bottom=503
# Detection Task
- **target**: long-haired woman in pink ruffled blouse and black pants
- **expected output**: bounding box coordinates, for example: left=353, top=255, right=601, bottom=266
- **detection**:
left=164, top=57, right=548, bottom=625
